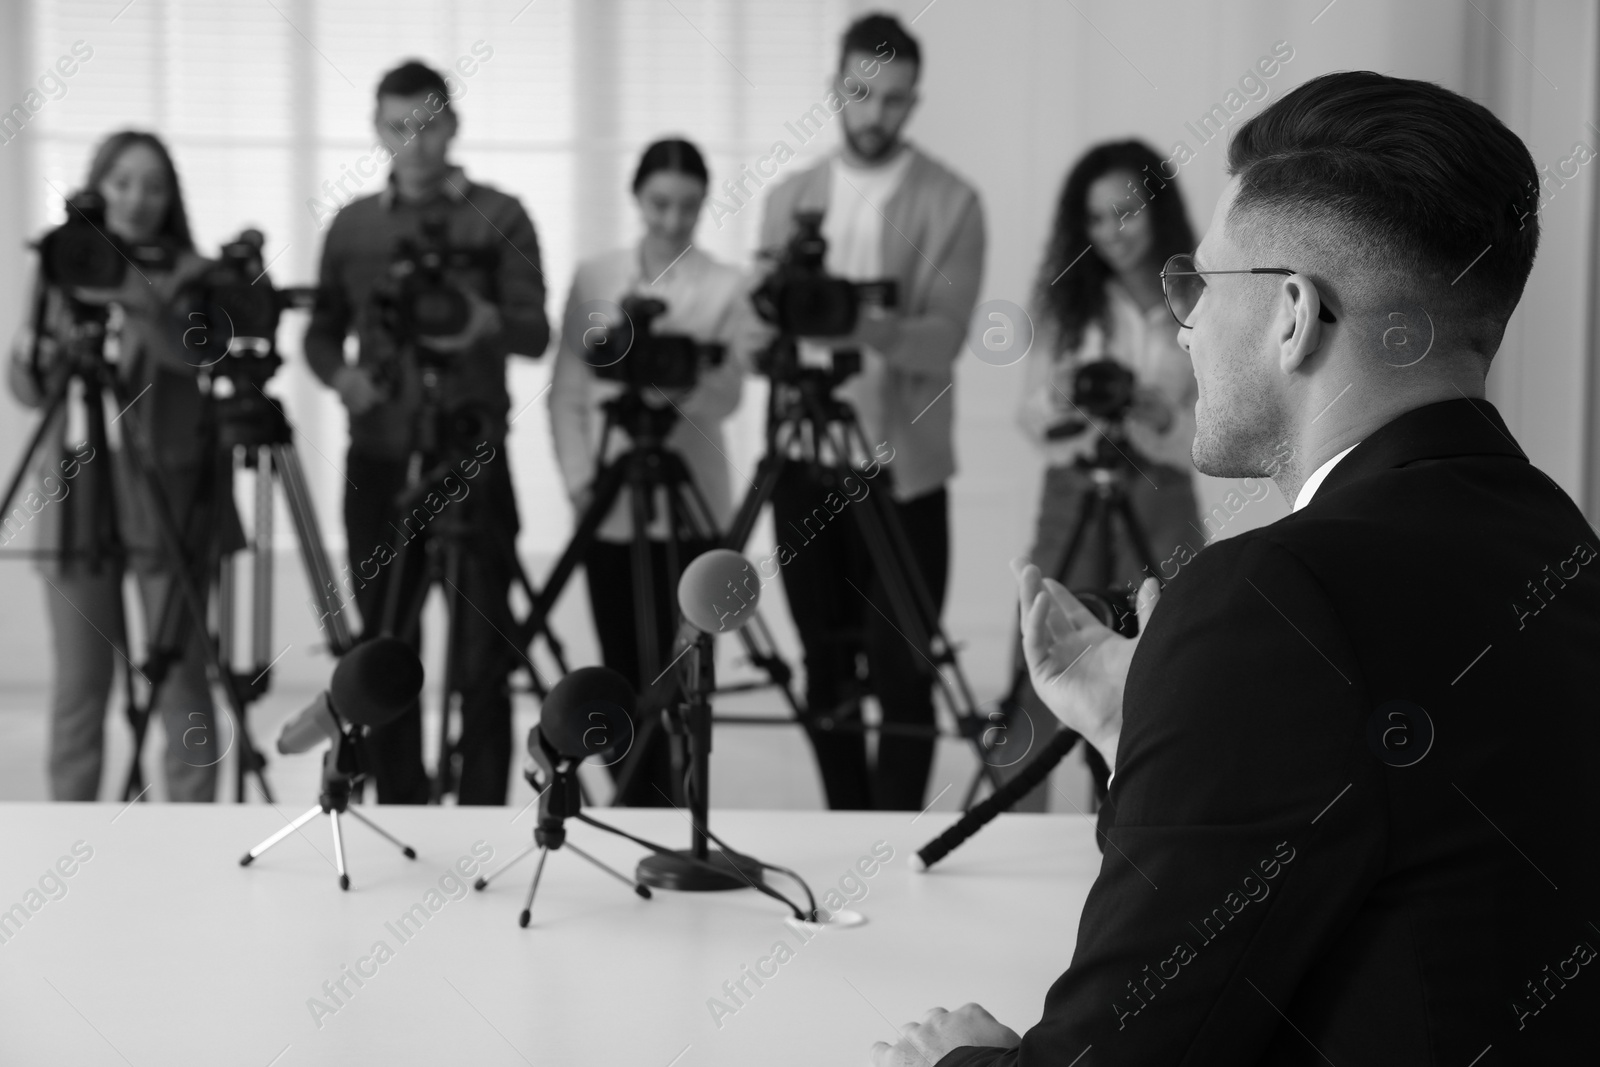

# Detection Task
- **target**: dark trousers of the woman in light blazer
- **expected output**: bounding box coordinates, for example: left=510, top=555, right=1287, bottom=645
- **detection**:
left=584, top=541, right=715, bottom=808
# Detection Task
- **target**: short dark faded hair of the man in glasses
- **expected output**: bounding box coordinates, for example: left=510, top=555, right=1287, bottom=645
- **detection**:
left=1227, top=70, right=1539, bottom=355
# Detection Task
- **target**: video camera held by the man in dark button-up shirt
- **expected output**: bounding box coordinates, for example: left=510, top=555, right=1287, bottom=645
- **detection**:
left=373, top=219, right=482, bottom=352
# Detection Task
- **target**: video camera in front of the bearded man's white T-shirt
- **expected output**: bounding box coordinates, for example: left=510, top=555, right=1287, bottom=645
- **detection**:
left=750, top=211, right=899, bottom=338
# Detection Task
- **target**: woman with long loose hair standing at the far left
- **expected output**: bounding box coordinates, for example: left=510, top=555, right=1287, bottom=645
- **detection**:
left=10, top=130, right=225, bottom=800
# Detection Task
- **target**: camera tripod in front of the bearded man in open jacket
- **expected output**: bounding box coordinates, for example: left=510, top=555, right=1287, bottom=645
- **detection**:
left=718, top=348, right=1000, bottom=808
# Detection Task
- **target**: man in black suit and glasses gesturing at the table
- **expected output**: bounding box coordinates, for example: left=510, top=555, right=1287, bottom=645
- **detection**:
left=874, top=72, right=1600, bottom=1067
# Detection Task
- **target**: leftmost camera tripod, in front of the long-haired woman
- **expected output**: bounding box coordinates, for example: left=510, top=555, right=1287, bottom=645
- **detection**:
left=0, top=292, right=272, bottom=801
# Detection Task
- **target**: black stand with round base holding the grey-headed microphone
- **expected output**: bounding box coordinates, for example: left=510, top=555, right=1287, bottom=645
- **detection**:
left=638, top=630, right=763, bottom=893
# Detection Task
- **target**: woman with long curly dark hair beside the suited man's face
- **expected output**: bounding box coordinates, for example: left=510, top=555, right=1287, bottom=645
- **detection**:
left=1019, top=141, right=1198, bottom=809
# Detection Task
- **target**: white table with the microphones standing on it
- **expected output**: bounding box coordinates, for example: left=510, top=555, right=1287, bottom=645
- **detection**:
left=0, top=803, right=1099, bottom=1067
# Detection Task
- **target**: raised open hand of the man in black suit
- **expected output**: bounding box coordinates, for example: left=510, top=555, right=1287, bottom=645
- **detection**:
left=1011, top=560, right=1162, bottom=768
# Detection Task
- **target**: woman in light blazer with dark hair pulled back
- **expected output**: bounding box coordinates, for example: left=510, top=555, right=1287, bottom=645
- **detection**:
left=550, top=139, right=763, bottom=806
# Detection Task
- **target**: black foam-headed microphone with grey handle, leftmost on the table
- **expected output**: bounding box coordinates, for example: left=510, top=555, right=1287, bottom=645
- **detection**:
left=278, top=637, right=422, bottom=755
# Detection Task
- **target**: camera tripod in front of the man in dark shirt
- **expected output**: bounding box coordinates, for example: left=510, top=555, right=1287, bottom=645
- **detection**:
left=381, top=358, right=566, bottom=805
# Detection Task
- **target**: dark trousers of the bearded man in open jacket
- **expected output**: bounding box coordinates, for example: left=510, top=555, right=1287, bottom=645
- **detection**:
left=773, top=464, right=950, bottom=811
